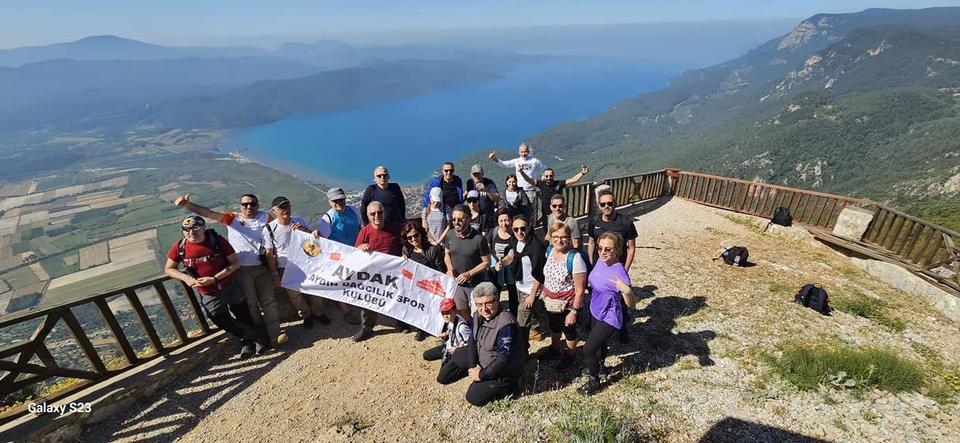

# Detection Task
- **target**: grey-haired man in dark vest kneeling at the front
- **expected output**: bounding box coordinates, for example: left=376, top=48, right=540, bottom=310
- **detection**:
left=467, top=282, right=527, bottom=406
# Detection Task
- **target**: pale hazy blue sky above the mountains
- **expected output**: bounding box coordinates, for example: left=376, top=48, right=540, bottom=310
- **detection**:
left=0, top=0, right=960, bottom=48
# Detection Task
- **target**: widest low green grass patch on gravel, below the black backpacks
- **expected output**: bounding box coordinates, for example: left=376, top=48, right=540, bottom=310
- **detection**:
left=768, top=345, right=925, bottom=392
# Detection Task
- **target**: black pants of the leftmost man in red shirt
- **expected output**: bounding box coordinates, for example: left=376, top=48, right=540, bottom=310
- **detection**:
left=200, top=281, right=270, bottom=346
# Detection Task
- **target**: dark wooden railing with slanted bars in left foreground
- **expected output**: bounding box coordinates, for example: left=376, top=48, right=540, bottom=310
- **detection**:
left=0, top=277, right=211, bottom=418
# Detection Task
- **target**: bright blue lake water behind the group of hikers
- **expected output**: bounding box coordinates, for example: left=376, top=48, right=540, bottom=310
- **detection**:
left=224, top=58, right=677, bottom=188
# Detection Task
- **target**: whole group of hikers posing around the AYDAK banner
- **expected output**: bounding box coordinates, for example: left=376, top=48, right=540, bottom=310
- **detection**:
left=165, top=144, right=637, bottom=406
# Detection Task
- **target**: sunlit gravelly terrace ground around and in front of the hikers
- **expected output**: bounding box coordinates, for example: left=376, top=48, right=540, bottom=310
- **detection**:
left=77, top=200, right=960, bottom=442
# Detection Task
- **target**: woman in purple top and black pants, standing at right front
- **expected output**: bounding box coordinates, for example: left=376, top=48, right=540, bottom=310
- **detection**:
left=579, top=231, right=635, bottom=395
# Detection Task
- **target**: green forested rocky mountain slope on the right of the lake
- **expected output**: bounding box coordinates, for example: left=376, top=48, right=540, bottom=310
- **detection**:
left=488, top=8, right=960, bottom=226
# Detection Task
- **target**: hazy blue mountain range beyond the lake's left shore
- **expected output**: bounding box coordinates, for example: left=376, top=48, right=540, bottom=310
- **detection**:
left=0, top=36, right=524, bottom=132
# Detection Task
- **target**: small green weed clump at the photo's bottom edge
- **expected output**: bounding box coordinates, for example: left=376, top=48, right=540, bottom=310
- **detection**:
left=549, top=402, right=640, bottom=442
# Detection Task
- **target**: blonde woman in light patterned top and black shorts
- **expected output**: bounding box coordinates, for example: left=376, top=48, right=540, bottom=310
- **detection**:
left=543, top=222, right=587, bottom=371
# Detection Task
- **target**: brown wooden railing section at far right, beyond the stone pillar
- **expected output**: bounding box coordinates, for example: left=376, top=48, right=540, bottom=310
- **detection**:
left=863, top=204, right=960, bottom=290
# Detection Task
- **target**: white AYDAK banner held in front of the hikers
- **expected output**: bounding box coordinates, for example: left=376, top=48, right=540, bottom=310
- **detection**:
left=281, top=231, right=457, bottom=335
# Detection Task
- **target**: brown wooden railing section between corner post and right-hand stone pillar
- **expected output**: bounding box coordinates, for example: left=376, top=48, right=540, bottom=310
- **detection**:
left=673, top=171, right=874, bottom=229
